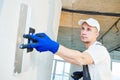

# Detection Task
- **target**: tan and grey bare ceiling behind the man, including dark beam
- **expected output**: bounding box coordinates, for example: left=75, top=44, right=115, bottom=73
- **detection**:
left=58, top=0, right=120, bottom=52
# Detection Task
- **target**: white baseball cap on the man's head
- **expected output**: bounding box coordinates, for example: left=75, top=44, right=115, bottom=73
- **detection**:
left=78, top=18, right=100, bottom=32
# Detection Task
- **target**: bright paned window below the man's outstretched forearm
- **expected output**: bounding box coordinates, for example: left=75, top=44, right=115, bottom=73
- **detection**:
left=51, top=59, right=70, bottom=80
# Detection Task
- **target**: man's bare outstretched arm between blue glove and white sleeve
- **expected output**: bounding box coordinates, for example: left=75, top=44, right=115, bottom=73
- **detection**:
left=56, top=45, right=93, bottom=65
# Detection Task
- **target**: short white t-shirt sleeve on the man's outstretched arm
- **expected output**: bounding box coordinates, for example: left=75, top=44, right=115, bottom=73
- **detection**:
left=85, top=45, right=108, bottom=64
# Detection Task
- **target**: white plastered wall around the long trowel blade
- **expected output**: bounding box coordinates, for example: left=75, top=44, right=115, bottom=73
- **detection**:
left=0, top=0, right=62, bottom=80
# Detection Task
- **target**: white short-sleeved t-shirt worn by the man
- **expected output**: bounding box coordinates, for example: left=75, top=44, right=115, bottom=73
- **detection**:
left=85, top=42, right=112, bottom=80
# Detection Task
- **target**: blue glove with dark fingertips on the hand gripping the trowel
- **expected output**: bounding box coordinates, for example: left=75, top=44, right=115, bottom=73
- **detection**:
left=20, top=33, right=59, bottom=54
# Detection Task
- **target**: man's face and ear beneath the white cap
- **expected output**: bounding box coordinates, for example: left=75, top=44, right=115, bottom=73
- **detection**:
left=80, top=22, right=99, bottom=43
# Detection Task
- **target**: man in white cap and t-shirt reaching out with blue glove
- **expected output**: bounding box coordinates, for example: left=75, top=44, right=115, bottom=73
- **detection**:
left=20, top=18, right=112, bottom=80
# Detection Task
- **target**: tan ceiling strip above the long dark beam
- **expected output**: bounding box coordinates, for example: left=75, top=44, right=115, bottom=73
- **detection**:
left=62, top=0, right=120, bottom=13
